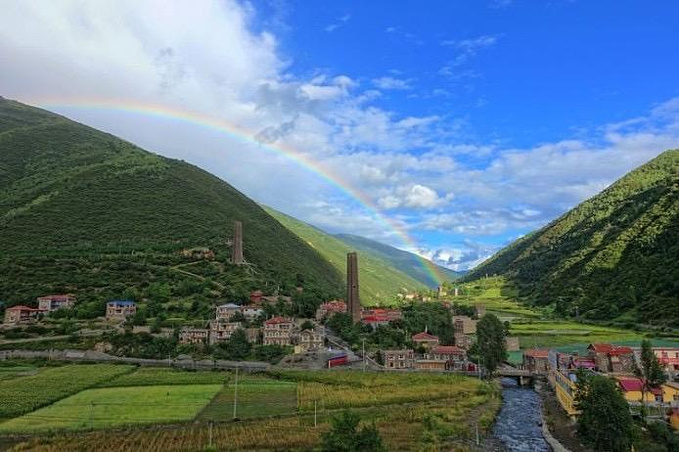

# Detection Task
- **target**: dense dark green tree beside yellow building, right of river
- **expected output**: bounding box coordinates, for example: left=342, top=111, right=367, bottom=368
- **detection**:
left=575, top=372, right=633, bottom=452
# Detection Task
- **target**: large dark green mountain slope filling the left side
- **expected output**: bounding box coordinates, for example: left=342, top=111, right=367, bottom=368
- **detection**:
left=0, top=98, right=343, bottom=317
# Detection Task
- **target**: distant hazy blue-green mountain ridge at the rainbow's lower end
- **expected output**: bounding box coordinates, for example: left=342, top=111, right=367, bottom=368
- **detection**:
left=335, top=234, right=461, bottom=288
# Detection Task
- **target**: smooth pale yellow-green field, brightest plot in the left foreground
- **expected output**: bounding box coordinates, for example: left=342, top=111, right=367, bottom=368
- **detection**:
left=0, top=385, right=221, bottom=433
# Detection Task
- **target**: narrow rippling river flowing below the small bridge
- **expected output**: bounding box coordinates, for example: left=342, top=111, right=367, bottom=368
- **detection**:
left=493, top=378, right=551, bottom=452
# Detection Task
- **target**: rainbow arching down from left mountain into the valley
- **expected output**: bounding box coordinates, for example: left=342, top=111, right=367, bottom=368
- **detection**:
left=31, top=98, right=441, bottom=285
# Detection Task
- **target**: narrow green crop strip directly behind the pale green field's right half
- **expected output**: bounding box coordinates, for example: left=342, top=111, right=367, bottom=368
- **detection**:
left=99, top=367, right=230, bottom=388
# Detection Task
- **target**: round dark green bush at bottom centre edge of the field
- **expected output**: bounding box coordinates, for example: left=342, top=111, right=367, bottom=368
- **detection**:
left=322, top=411, right=385, bottom=452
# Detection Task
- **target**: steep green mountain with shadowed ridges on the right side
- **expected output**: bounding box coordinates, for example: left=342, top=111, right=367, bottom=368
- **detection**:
left=465, top=150, right=679, bottom=326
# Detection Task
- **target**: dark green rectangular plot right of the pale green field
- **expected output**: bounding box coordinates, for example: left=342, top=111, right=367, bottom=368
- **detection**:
left=198, top=376, right=297, bottom=422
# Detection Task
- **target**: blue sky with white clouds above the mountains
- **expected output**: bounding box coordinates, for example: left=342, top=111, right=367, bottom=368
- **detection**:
left=0, top=0, right=679, bottom=269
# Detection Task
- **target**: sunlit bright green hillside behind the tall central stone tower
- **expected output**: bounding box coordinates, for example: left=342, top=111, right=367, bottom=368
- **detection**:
left=264, top=207, right=425, bottom=305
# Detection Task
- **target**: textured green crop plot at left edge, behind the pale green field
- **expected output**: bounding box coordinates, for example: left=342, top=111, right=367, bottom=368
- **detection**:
left=0, top=364, right=133, bottom=419
